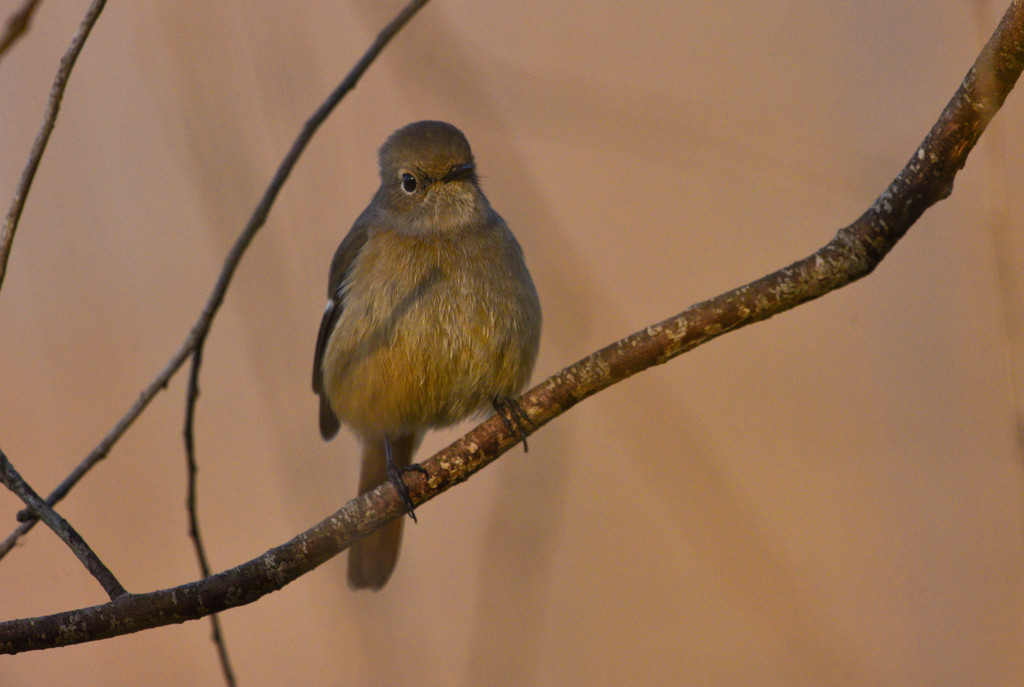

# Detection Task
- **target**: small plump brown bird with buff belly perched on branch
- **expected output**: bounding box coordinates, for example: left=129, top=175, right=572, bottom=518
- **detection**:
left=313, top=122, right=541, bottom=589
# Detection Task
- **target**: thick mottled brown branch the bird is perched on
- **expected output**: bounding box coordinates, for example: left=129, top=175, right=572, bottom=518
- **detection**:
left=0, top=0, right=1024, bottom=653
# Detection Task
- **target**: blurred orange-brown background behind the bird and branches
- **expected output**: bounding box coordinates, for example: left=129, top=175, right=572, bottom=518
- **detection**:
left=0, top=0, right=1024, bottom=687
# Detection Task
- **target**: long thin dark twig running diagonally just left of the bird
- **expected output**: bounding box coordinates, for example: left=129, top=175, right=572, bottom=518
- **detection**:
left=0, top=0, right=429, bottom=558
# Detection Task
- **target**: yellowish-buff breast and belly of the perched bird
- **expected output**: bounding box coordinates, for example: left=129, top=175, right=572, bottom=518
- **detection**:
left=324, top=231, right=536, bottom=435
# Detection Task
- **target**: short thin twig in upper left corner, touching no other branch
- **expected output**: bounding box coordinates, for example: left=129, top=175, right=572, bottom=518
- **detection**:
left=0, top=0, right=106, bottom=287
